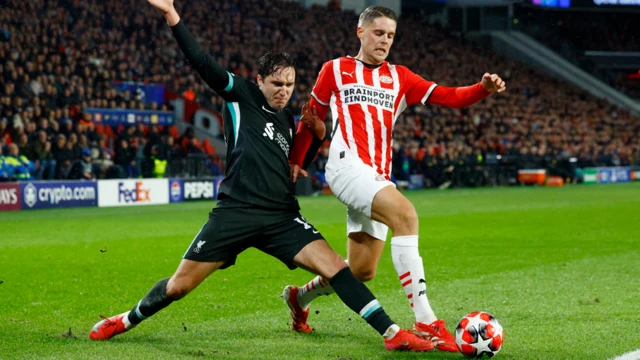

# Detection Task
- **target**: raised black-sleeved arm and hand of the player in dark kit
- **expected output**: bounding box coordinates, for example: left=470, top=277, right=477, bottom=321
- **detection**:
left=147, top=0, right=233, bottom=92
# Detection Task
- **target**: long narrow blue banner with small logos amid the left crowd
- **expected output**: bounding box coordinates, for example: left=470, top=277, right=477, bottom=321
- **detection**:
left=84, top=108, right=175, bottom=125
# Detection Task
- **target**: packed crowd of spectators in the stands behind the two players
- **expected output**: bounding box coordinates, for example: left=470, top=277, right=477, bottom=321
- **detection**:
left=0, top=0, right=640, bottom=186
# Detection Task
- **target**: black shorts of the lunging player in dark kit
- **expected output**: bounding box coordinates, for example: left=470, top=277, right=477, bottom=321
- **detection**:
left=183, top=207, right=324, bottom=270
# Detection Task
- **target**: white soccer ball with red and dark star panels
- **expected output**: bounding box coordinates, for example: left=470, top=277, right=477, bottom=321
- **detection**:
left=456, top=311, right=504, bottom=359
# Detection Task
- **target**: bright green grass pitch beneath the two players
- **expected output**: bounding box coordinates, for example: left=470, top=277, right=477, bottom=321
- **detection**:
left=0, top=184, right=640, bottom=360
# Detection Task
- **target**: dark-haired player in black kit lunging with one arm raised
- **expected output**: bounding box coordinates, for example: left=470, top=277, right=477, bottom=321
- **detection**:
left=89, top=0, right=434, bottom=351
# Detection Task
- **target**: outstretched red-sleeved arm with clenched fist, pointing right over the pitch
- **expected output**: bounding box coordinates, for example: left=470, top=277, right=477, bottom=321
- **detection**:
left=405, top=68, right=506, bottom=108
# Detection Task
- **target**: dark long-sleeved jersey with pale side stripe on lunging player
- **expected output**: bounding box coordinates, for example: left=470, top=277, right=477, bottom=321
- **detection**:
left=172, top=21, right=299, bottom=210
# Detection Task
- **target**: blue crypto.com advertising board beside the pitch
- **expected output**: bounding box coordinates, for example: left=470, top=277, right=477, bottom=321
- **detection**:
left=20, top=181, right=98, bottom=210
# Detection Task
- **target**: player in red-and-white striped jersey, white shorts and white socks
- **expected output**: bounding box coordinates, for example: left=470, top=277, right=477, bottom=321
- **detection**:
left=284, top=6, right=506, bottom=352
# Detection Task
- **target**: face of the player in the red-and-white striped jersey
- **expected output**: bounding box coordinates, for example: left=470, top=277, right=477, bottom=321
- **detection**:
left=358, top=16, right=397, bottom=65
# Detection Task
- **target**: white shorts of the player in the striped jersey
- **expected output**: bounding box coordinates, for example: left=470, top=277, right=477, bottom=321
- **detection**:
left=326, top=152, right=395, bottom=241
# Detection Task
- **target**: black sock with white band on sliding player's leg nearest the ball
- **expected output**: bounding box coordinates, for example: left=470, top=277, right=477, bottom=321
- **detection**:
left=329, top=266, right=395, bottom=335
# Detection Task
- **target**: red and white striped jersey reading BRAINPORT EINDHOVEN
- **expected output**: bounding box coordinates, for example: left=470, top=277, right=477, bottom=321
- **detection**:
left=311, top=57, right=436, bottom=179
